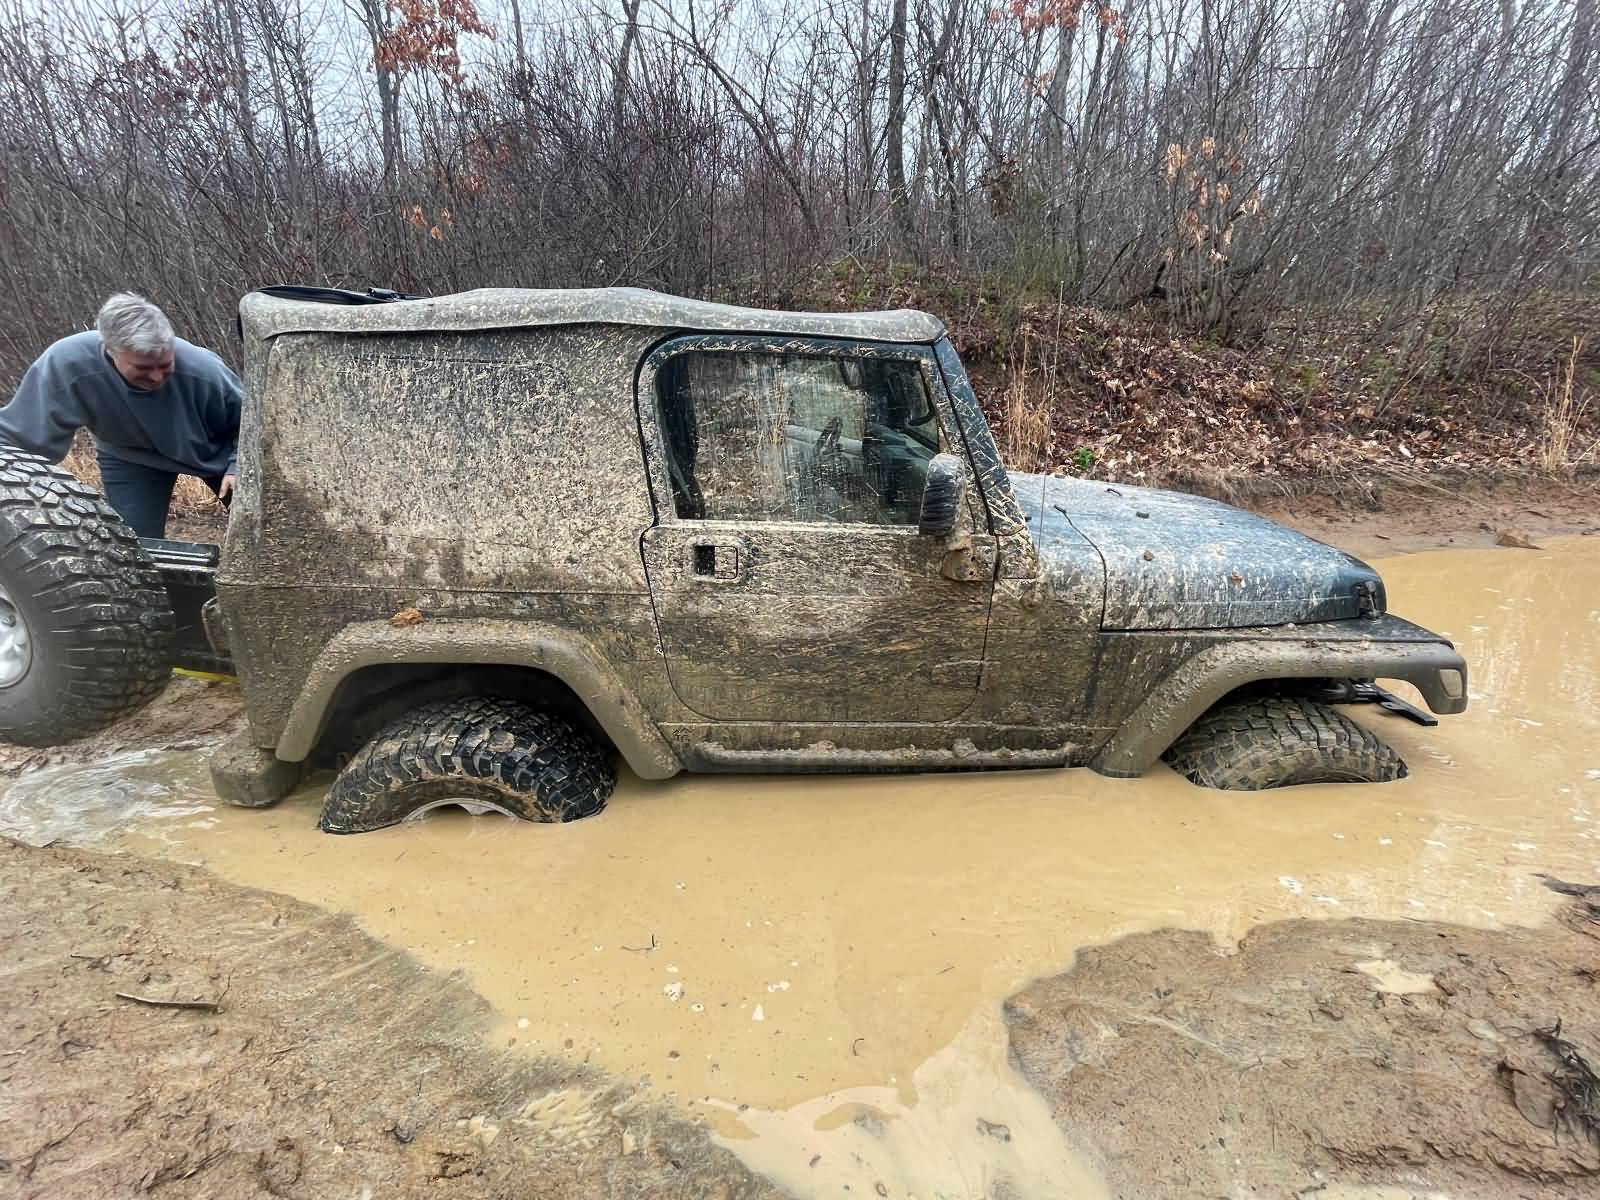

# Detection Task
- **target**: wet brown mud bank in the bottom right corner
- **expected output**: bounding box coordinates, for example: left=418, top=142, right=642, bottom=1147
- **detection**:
left=1005, top=888, right=1600, bottom=1200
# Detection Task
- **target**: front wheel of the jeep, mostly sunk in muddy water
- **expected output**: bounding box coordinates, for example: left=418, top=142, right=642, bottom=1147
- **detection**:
left=1162, top=696, right=1406, bottom=792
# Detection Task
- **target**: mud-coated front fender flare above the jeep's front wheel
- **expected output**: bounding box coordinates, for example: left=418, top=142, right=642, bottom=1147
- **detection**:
left=1090, top=638, right=1467, bottom=779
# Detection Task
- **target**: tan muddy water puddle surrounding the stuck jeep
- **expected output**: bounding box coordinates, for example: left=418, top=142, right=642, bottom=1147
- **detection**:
left=0, top=539, right=1600, bottom=1197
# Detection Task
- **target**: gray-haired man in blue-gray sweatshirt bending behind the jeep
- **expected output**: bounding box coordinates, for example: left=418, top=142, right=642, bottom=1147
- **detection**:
left=0, top=291, right=242, bottom=538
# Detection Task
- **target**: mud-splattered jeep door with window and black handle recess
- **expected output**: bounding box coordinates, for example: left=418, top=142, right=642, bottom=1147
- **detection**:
left=638, top=336, right=995, bottom=723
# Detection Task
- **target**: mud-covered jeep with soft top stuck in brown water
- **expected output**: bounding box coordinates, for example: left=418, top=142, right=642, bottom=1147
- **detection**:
left=0, top=288, right=1467, bottom=832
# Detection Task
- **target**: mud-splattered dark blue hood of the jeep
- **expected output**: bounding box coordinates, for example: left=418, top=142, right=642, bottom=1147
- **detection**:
left=1011, top=472, right=1387, bottom=629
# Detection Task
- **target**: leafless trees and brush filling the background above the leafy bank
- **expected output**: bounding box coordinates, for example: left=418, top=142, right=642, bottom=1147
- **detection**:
left=0, top=0, right=1600, bottom=387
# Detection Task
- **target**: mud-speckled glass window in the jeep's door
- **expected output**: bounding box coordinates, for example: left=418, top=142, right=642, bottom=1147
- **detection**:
left=656, top=350, right=941, bottom=525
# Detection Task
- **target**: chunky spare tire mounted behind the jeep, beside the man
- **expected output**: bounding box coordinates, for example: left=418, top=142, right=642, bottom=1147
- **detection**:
left=0, top=446, right=173, bottom=746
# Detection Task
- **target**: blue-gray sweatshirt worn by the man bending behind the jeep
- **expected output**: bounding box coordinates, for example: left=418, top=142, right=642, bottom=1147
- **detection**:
left=0, top=330, right=242, bottom=477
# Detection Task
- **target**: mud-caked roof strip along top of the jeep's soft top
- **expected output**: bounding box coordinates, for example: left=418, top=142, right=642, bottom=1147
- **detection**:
left=238, top=288, right=944, bottom=342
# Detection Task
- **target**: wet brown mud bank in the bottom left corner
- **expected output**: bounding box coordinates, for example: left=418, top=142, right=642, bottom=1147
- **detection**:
left=0, top=842, right=781, bottom=1200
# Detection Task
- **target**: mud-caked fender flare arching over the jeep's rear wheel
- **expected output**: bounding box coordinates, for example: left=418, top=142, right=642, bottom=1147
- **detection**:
left=275, top=619, right=683, bottom=779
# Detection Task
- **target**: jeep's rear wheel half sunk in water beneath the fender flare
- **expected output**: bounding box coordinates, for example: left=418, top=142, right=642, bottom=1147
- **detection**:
left=320, top=696, right=616, bottom=834
